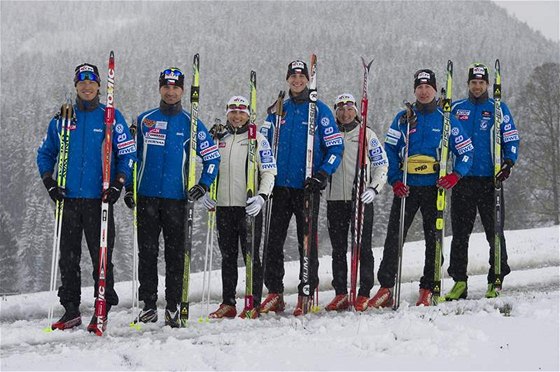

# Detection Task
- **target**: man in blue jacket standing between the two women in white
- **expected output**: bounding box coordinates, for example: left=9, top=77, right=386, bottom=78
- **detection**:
left=260, top=60, right=344, bottom=316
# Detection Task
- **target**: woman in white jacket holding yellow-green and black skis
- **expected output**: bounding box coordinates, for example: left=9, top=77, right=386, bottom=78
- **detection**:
left=204, top=96, right=276, bottom=318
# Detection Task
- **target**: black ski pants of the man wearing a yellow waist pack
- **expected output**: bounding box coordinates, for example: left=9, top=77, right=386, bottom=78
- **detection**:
left=377, top=186, right=443, bottom=290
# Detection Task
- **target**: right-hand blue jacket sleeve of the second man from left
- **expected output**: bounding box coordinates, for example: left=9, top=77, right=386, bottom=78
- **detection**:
left=196, top=119, right=220, bottom=188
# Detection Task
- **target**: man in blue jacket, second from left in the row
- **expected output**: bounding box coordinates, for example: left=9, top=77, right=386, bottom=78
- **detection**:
left=125, top=67, right=220, bottom=328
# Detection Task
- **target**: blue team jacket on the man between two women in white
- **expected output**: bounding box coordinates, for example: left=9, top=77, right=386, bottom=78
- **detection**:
left=260, top=98, right=344, bottom=189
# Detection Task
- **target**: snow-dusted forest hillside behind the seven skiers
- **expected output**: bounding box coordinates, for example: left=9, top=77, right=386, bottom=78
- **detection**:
left=0, top=1, right=560, bottom=293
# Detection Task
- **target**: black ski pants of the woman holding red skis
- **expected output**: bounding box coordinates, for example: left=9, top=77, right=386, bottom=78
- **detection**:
left=327, top=200, right=374, bottom=297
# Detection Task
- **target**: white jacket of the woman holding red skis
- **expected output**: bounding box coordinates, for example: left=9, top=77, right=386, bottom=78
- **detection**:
left=326, top=125, right=389, bottom=201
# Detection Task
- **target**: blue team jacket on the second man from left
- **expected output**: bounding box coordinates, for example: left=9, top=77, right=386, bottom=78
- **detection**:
left=136, top=108, right=220, bottom=200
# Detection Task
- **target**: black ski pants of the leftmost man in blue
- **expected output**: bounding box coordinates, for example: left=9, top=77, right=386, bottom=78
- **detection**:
left=58, top=198, right=119, bottom=306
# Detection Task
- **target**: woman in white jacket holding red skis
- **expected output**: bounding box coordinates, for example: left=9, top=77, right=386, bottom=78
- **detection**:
left=326, top=93, right=389, bottom=311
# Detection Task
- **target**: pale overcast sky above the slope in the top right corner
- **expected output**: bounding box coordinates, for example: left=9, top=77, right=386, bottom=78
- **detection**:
left=494, top=0, right=560, bottom=42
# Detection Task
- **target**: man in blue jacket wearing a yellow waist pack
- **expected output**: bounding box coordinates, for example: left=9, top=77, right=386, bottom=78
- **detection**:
left=368, top=69, right=473, bottom=308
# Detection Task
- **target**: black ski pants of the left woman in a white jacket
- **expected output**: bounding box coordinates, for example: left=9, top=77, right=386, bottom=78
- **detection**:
left=216, top=207, right=263, bottom=306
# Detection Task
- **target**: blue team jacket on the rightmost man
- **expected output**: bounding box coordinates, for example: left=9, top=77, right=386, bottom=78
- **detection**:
left=451, top=98, right=519, bottom=177
